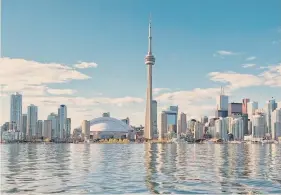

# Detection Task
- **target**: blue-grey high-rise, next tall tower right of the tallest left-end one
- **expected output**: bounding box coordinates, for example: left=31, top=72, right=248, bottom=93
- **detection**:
left=27, top=104, right=38, bottom=139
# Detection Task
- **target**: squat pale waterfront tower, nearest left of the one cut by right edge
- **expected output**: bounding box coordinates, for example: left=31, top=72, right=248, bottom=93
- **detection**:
left=252, top=114, right=266, bottom=138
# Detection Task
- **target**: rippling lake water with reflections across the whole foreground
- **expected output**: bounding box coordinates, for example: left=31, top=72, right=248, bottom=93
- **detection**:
left=1, top=143, right=281, bottom=194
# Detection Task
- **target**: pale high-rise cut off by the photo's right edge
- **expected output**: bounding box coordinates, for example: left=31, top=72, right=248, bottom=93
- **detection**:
left=271, top=108, right=281, bottom=140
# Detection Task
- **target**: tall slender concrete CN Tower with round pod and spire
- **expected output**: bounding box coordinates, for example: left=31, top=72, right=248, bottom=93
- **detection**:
left=144, top=17, right=155, bottom=139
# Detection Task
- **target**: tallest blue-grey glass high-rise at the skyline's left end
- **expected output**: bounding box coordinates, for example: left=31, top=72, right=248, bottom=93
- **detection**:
left=10, top=93, right=22, bottom=131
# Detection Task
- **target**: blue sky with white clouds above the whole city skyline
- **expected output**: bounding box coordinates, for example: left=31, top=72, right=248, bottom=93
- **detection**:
left=0, top=0, right=281, bottom=128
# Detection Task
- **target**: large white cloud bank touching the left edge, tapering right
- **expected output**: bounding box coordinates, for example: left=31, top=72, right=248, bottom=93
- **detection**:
left=0, top=58, right=90, bottom=90
